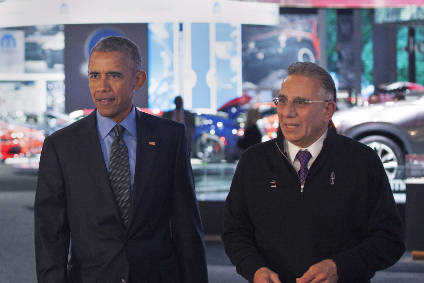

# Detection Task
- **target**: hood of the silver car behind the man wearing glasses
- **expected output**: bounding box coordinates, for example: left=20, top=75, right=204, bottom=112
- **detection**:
left=333, top=98, right=424, bottom=133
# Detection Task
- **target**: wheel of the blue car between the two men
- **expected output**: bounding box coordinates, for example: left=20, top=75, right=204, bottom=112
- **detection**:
left=195, top=134, right=225, bottom=163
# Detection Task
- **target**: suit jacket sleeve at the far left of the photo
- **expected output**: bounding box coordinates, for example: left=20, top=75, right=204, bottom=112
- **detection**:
left=34, top=137, right=69, bottom=283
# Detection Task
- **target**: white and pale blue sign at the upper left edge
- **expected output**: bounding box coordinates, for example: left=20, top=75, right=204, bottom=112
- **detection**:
left=0, top=30, right=25, bottom=73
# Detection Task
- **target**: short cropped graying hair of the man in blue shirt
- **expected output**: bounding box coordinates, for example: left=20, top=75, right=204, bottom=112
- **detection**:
left=89, top=36, right=141, bottom=71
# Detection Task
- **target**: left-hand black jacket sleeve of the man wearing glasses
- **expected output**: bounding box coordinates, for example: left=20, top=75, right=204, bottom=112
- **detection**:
left=222, top=152, right=267, bottom=282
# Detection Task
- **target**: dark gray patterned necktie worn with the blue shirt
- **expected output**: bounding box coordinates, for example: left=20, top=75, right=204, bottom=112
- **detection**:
left=109, top=124, right=131, bottom=227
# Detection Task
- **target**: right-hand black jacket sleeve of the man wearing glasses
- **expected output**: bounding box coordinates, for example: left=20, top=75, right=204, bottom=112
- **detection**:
left=332, top=152, right=405, bottom=282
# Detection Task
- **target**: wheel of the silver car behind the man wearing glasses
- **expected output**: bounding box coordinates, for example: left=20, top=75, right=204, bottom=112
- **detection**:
left=359, top=136, right=405, bottom=179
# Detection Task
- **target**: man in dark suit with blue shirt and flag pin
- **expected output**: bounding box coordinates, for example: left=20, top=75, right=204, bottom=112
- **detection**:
left=35, top=37, right=207, bottom=283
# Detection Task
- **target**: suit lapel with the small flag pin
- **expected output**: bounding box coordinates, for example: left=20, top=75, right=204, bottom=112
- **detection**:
left=130, top=111, right=160, bottom=226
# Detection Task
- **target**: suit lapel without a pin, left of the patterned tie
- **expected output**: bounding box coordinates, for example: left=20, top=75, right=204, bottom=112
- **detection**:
left=78, top=111, right=122, bottom=226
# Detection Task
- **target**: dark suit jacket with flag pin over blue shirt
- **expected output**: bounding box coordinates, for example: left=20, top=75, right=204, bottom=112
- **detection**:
left=35, top=111, right=207, bottom=283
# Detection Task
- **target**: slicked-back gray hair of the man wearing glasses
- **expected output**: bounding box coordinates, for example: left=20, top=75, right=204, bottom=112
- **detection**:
left=287, top=62, right=336, bottom=101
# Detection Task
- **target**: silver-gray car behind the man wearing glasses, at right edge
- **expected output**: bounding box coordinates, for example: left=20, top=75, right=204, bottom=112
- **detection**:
left=333, top=93, right=424, bottom=178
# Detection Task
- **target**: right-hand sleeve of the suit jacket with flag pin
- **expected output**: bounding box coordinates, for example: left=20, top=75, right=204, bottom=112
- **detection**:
left=172, top=125, right=208, bottom=283
